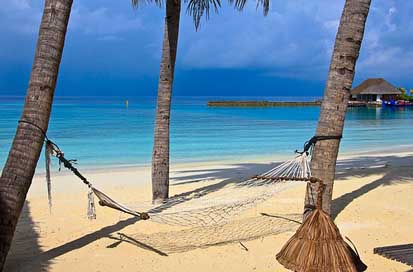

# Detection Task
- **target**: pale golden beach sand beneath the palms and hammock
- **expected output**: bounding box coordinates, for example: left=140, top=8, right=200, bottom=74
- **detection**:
left=5, top=151, right=413, bottom=272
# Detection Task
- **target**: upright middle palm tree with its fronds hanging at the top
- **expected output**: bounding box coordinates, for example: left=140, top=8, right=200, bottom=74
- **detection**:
left=132, top=0, right=269, bottom=203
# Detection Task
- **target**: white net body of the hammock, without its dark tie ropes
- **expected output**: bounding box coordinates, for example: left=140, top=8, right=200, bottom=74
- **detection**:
left=91, top=153, right=311, bottom=227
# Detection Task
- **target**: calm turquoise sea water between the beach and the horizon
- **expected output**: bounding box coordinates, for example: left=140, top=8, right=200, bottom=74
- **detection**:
left=0, top=97, right=413, bottom=168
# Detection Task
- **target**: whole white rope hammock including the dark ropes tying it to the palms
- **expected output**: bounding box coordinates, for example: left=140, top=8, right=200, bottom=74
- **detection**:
left=45, top=136, right=340, bottom=226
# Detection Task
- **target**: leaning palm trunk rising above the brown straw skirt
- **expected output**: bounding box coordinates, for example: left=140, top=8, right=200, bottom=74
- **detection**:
left=304, top=0, right=371, bottom=215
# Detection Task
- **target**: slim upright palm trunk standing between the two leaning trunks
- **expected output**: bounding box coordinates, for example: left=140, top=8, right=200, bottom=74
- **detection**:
left=152, top=0, right=181, bottom=203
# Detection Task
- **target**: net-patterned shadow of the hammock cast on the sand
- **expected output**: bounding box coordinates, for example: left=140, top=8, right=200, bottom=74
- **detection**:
left=111, top=213, right=302, bottom=255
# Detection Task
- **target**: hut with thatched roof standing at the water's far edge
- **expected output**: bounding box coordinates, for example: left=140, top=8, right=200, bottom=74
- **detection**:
left=350, top=78, right=402, bottom=104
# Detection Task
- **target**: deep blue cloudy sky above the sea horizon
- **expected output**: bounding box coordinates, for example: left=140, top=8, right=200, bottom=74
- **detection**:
left=0, top=0, right=413, bottom=96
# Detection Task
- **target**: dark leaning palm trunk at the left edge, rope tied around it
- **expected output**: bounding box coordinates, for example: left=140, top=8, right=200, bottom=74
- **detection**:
left=0, top=0, right=72, bottom=271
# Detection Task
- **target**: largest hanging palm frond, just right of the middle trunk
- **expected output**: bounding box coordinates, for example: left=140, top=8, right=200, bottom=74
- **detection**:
left=186, top=0, right=221, bottom=30
